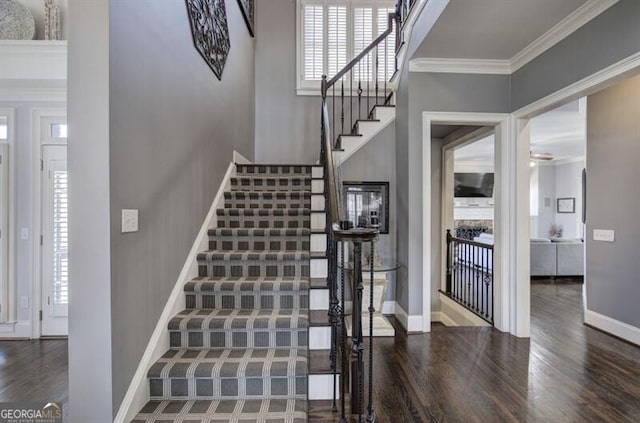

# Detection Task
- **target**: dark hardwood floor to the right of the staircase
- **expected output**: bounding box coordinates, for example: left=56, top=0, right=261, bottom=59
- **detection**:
left=309, top=281, right=640, bottom=423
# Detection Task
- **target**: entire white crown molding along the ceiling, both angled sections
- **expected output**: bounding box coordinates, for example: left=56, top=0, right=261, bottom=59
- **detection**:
left=409, top=0, right=619, bottom=75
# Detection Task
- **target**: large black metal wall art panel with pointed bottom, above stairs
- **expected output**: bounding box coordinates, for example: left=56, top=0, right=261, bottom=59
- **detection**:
left=186, top=0, right=231, bottom=80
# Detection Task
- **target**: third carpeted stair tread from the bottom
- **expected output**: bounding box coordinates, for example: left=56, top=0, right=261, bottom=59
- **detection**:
left=168, top=309, right=309, bottom=331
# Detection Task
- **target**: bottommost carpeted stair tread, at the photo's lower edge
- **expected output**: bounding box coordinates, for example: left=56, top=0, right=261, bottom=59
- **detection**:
left=131, top=398, right=307, bottom=423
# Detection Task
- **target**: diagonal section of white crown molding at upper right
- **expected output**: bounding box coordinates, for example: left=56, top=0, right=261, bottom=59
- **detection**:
left=510, top=0, right=619, bottom=72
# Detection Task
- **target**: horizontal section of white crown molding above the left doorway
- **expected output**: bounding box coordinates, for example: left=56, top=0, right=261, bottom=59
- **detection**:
left=409, top=57, right=511, bottom=75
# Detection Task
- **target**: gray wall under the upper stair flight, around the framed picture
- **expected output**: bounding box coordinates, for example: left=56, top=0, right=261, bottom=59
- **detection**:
left=339, top=124, right=397, bottom=301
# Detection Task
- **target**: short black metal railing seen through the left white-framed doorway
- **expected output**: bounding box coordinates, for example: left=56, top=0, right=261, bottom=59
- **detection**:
left=444, top=230, right=494, bottom=325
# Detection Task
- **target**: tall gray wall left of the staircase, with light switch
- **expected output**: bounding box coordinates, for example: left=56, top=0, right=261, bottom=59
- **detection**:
left=69, top=0, right=255, bottom=421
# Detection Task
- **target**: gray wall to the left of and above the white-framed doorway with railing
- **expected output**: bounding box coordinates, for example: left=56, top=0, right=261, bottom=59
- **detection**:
left=396, top=73, right=510, bottom=315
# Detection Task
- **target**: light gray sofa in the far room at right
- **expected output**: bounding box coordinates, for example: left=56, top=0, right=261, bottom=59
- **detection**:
left=531, top=238, right=584, bottom=277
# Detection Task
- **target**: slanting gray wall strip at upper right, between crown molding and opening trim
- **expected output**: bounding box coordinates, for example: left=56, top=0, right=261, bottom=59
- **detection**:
left=511, top=0, right=640, bottom=110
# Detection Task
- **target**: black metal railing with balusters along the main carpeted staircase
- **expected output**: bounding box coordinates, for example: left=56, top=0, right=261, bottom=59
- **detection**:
left=320, top=1, right=406, bottom=423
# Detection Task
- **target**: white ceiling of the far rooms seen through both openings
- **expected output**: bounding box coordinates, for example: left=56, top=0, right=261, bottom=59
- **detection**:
left=455, top=98, right=586, bottom=163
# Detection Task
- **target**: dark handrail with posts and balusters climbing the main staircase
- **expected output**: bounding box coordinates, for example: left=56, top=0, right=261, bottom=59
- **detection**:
left=320, top=3, right=400, bottom=423
